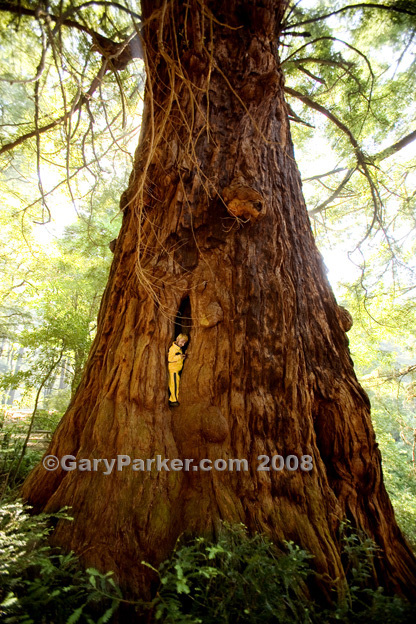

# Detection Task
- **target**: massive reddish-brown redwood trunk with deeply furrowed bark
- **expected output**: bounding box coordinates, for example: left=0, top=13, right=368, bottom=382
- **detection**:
left=24, top=0, right=416, bottom=595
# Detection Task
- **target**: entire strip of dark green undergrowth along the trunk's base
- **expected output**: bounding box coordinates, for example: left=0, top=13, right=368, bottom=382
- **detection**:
left=0, top=500, right=416, bottom=624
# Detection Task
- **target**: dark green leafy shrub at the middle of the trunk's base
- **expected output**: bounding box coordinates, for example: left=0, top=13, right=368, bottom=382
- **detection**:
left=151, top=526, right=309, bottom=624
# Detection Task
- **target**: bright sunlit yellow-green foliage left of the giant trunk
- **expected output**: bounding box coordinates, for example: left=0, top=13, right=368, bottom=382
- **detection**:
left=0, top=0, right=133, bottom=406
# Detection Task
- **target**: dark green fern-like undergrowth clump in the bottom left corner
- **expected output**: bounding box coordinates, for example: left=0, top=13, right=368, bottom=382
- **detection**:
left=0, top=501, right=122, bottom=624
